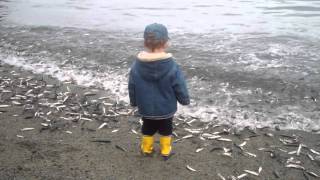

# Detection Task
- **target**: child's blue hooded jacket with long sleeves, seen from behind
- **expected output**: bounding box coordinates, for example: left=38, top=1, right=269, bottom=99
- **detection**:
left=128, top=52, right=190, bottom=119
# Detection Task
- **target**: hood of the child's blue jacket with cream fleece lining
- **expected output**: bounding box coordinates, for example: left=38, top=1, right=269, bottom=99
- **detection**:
left=136, top=52, right=174, bottom=81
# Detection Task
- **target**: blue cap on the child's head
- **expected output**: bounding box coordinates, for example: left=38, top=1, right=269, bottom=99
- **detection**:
left=143, top=23, right=169, bottom=40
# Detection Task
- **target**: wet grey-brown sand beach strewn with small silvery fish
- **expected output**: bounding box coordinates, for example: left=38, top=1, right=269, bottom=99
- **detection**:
left=0, top=64, right=320, bottom=180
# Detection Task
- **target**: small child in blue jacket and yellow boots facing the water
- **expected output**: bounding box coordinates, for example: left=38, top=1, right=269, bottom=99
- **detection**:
left=128, top=23, right=190, bottom=157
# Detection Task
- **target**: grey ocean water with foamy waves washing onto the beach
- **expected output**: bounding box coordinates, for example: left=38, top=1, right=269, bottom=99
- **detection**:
left=0, top=0, right=320, bottom=131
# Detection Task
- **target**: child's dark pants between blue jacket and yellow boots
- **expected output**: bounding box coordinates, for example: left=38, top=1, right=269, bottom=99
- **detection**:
left=141, top=118, right=172, bottom=136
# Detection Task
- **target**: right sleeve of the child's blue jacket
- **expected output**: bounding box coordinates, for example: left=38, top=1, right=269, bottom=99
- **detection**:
left=173, top=66, right=190, bottom=105
